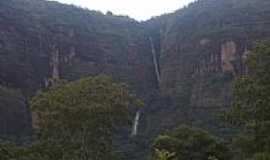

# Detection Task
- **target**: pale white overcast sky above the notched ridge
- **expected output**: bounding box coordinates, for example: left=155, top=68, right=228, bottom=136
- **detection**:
left=53, top=0, right=194, bottom=20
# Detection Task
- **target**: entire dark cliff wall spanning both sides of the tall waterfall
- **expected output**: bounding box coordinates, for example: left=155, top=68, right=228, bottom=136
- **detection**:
left=0, top=0, right=270, bottom=157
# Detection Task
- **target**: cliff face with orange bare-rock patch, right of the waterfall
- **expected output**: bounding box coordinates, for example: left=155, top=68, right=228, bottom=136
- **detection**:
left=138, top=0, right=270, bottom=142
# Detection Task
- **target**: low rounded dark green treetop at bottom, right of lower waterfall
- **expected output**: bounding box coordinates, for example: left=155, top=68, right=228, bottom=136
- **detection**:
left=153, top=126, right=230, bottom=160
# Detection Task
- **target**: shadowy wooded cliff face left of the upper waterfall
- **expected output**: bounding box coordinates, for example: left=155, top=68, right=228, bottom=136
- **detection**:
left=0, top=0, right=157, bottom=140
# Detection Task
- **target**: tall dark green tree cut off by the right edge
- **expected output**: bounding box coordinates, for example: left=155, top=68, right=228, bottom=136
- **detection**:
left=228, top=42, right=270, bottom=159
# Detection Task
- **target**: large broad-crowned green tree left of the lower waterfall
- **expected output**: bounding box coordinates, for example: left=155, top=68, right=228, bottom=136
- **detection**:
left=16, top=76, right=142, bottom=160
